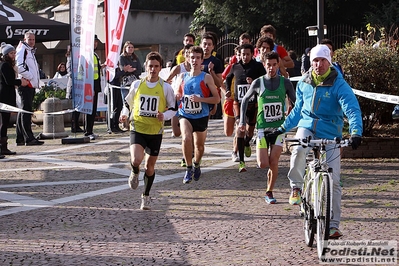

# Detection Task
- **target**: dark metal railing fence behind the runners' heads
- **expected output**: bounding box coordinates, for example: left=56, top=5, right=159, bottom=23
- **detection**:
left=217, top=25, right=361, bottom=61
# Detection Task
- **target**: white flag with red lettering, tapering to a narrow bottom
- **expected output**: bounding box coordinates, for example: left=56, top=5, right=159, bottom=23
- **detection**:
left=104, top=0, right=131, bottom=81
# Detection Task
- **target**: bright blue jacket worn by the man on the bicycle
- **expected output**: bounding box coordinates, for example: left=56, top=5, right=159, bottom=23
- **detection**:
left=281, top=67, right=363, bottom=139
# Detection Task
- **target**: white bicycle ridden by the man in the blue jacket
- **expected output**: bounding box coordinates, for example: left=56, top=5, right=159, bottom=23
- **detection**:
left=285, top=136, right=350, bottom=258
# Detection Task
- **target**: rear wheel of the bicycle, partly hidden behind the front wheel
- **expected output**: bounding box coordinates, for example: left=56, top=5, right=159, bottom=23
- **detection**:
left=301, top=176, right=316, bottom=247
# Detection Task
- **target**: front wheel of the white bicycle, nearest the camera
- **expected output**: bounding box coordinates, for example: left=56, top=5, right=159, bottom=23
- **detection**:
left=317, top=174, right=331, bottom=258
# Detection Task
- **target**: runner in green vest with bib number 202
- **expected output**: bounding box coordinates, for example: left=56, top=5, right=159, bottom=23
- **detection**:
left=239, top=52, right=295, bottom=204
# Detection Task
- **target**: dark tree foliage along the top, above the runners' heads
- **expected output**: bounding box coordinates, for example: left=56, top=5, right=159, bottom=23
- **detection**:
left=191, top=0, right=398, bottom=40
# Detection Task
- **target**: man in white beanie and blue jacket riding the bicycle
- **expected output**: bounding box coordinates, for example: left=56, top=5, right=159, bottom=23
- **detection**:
left=272, top=44, right=363, bottom=238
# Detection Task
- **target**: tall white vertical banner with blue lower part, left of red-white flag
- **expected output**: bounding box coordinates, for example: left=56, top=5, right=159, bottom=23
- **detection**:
left=70, top=0, right=97, bottom=114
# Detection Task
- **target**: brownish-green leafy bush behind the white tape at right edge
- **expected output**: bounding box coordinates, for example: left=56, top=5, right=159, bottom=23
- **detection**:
left=334, top=26, right=399, bottom=136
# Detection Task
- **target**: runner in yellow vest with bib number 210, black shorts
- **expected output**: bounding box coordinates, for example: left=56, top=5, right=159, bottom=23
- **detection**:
left=120, top=52, right=176, bottom=210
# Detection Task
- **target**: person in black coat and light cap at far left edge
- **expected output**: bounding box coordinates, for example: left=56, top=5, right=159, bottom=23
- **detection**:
left=0, top=42, right=29, bottom=158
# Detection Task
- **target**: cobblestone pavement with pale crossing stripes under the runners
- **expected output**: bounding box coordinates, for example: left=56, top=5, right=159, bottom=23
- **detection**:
left=0, top=120, right=399, bottom=265
